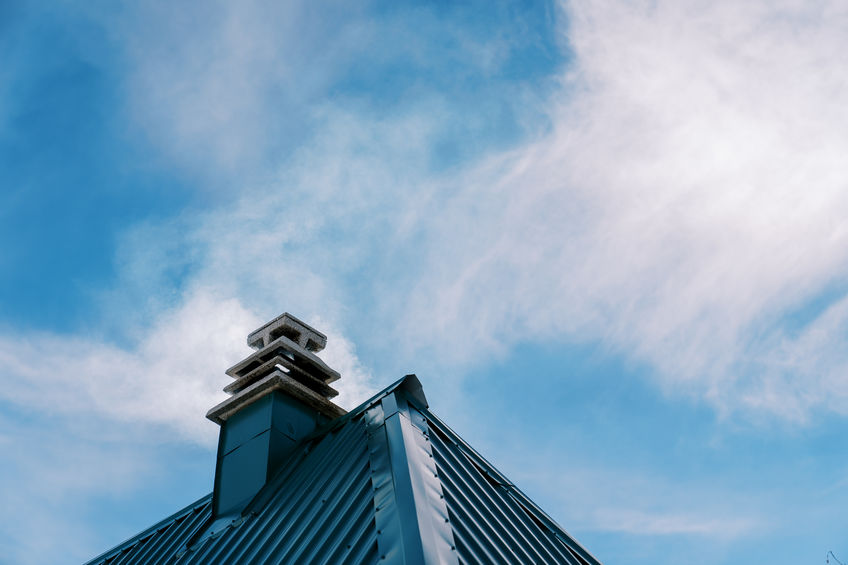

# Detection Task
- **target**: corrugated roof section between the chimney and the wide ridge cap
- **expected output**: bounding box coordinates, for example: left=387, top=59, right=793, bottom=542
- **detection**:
left=187, top=418, right=377, bottom=563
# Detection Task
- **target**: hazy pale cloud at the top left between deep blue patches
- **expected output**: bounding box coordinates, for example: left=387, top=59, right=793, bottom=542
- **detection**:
left=112, top=0, right=371, bottom=176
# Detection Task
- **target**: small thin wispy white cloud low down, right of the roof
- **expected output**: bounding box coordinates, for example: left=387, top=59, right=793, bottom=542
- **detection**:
left=514, top=460, right=764, bottom=540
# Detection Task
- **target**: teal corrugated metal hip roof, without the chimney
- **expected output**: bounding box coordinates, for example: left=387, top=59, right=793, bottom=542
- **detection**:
left=88, top=375, right=600, bottom=565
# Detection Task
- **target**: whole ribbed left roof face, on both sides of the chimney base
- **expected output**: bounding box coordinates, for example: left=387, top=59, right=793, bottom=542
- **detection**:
left=91, top=418, right=378, bottom=565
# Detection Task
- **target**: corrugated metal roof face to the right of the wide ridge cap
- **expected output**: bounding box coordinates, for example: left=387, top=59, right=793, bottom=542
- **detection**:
left=424, top=411, right=600, bottom=565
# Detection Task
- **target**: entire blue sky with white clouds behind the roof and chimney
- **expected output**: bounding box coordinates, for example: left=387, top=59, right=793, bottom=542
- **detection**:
left=0, top=0, right=848, bottom=565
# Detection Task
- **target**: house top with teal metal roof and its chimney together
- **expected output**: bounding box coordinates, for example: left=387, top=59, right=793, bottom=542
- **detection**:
left=84, top=314, right=600, bottom=565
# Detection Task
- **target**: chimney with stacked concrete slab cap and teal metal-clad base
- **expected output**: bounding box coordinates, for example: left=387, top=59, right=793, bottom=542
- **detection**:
left=206, top=312, right=345, bottom=518
